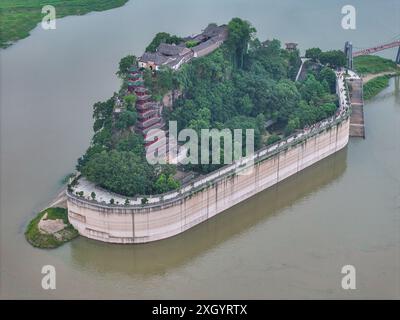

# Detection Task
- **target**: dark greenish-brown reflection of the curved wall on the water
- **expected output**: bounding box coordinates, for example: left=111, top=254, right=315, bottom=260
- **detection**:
left=71, top=148, right=347, bottom=277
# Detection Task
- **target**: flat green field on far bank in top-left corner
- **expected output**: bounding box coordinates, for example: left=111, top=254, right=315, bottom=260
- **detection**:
left=0, top=0, right=128, bottom=48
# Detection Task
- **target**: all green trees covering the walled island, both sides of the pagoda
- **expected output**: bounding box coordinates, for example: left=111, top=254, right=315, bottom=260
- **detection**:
left=72, top=18, right=345, bottom=197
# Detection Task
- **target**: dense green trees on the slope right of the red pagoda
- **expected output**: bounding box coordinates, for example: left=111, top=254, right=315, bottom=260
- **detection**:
left=162, top=18, right=336, bottom=172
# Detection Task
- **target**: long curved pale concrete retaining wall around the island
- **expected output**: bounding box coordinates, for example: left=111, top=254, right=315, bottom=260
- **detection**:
left=68, top=116, right=349, bottom=243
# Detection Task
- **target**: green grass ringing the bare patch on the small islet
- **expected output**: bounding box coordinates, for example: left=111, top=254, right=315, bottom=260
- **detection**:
left=25, top=208, right=79, bottom=249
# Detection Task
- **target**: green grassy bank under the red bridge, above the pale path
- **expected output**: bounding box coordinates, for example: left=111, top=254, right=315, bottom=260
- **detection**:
left=354, top=56, right=400, bottom=75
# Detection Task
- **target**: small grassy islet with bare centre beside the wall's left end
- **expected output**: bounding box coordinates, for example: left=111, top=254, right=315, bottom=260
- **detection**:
left=25, top=207, right=79, bottom=249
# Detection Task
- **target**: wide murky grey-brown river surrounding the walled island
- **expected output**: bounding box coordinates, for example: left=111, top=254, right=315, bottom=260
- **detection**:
left=0, top=0, right=400, bottom=299
